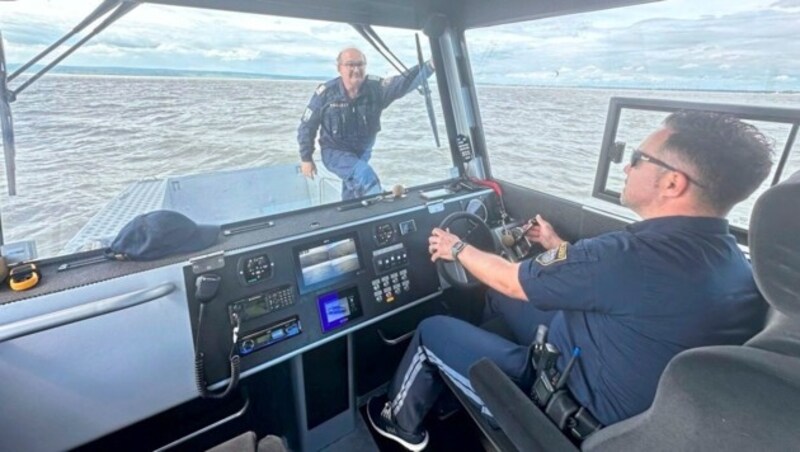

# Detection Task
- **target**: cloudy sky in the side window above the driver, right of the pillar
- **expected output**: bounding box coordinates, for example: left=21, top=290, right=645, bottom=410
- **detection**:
left=468, top=0, right=800, bottom=89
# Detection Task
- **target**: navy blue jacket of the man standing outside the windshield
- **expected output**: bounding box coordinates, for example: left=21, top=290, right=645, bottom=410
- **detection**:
left=297, top=63, right=433, bottom=162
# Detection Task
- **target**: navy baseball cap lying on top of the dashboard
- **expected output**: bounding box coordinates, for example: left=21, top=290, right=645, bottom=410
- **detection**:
left=109, top=210, right=220, bottom=261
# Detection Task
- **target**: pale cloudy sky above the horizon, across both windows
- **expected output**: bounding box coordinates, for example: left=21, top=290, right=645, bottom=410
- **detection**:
left=0, top=0, right=800, bottom=91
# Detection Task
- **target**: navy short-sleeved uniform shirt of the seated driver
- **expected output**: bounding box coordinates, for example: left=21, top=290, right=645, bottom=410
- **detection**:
left=519, top=217, right=767, bottom=425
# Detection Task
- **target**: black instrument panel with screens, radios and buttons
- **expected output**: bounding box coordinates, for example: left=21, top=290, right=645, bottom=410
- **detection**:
left=184, top=192, right=487, bottom=384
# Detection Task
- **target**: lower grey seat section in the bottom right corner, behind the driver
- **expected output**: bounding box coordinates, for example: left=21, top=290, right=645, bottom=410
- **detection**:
left=582, top=346, right=800, bottom=451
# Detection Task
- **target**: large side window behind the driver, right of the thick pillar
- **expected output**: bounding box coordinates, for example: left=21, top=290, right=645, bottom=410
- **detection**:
left=466, top=0, right=800, bottom=230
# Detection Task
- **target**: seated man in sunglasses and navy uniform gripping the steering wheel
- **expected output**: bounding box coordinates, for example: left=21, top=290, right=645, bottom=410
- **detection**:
left=367, top=111, right=772, bottom=450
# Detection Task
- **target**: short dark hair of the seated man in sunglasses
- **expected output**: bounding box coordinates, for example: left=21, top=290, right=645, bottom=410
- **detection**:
left=663, top=110, right=772, bottom=215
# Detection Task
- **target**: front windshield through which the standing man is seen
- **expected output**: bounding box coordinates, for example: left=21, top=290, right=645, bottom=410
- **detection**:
left=0, top=0, right=453, bottom=258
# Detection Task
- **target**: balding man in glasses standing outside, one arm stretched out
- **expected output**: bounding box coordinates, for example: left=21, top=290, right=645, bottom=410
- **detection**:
left=297, top=48, right=433, bottom=200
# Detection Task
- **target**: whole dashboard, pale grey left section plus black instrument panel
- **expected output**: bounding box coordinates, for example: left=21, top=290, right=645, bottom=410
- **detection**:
left=0, top=185, right=496, bottom=450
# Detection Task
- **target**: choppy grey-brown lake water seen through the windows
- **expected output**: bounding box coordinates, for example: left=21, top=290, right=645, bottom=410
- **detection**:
left=0, top=76, right=800, bottom=257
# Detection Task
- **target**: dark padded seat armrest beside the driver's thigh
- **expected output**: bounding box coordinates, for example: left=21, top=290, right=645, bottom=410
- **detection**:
left=469, top=358, right=578, bottom=452
